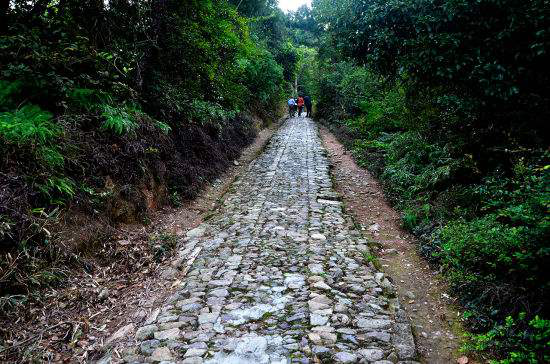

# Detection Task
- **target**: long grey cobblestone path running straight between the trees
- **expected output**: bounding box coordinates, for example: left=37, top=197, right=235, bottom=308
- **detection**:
left=106, top=118, right=416, bottom=364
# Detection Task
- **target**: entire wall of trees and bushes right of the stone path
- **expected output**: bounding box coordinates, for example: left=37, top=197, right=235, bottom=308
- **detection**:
left=314, top=0, right=550, bottom=363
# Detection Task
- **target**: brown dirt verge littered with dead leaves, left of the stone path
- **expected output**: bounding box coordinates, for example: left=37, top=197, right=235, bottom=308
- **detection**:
left=0, top=118, right=278, bottom=362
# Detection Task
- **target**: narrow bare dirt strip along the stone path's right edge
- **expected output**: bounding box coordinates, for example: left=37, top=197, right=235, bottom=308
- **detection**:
left=320, top=127, right=472, bottom=363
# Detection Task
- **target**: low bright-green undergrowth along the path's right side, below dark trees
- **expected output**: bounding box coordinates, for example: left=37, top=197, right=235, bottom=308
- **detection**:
left=317, top=61, right=550, bottom=364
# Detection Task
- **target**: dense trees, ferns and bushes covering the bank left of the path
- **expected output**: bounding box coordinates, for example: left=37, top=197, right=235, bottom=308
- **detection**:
left=0, top=0, right=285, bottom=308
